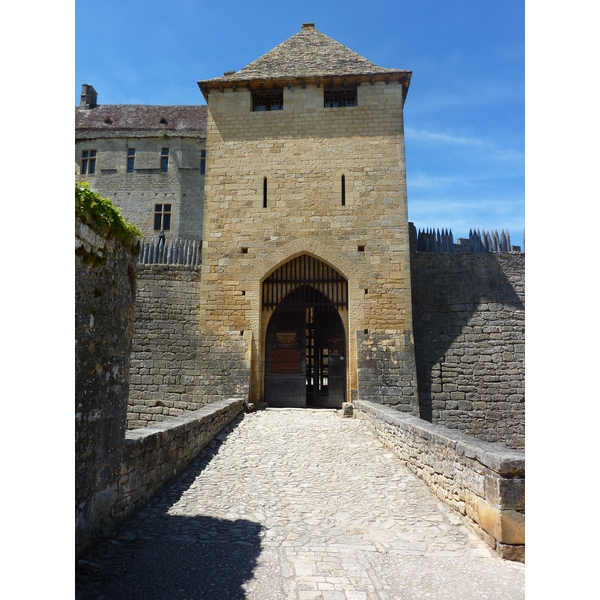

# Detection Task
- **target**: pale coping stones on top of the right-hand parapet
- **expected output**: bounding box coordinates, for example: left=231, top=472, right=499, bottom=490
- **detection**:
left=354, top=400, right=525, bottom=477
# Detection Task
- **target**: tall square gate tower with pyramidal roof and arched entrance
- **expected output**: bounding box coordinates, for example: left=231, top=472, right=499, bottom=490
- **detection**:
left=198, top=23, right=418, bottom=414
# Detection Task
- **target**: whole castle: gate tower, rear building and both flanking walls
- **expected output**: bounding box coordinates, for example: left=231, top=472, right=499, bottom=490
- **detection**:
left=75, top=23, right=524, bottom=446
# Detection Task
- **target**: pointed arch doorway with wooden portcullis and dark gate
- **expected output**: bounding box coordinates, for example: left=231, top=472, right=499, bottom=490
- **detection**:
left=262, top=254, right=348, bottom=408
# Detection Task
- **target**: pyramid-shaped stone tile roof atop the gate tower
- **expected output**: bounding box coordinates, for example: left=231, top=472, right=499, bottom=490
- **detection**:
left=198, top=23, right=411, bottom=87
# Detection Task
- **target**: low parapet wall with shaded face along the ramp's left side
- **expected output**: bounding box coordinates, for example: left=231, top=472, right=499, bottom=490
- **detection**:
left=111, top=398, right=244, bottom=524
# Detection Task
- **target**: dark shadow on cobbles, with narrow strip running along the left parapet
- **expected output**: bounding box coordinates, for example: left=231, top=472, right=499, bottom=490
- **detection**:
left=76, top=417, right=264, bottom=600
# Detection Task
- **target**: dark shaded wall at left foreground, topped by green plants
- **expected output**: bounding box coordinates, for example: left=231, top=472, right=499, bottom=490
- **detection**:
left=75, top=221, right=137, bottom=554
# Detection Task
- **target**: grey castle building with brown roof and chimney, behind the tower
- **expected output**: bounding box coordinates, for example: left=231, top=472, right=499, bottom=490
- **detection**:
left=75, top=84, right=206, bottom=240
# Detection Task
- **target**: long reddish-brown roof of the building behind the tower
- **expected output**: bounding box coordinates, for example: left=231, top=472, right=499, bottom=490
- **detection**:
left=75, top=104, right=207, bottom=132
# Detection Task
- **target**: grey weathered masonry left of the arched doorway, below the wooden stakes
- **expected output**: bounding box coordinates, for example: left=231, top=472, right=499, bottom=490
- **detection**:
left=127, top=264, right=249, bottom=429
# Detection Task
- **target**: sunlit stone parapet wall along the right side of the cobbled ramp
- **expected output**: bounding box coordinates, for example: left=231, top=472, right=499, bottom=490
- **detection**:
left=355, top=400, right=525, bottom=562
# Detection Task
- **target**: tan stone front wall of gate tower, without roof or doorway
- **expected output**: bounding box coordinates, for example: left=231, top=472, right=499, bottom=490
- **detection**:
left=200, top=82, right=417, bottom=411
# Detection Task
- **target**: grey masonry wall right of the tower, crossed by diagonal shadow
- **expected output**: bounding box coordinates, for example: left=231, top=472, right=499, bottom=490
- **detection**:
left=411, top=253, right=525, bottom=448
